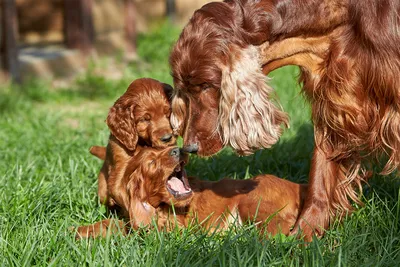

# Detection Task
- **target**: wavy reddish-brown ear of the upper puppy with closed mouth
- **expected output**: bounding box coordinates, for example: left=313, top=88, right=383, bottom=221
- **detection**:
left=106, top=104, right=138, bottom=150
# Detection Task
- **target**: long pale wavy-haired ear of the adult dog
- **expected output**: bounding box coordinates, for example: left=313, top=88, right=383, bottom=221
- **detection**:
left=218, top=46, right=288, bottom=155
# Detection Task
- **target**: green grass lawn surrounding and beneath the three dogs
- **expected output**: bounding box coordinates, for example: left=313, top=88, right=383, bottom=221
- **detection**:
left=0, top=22, right=400, bottom=266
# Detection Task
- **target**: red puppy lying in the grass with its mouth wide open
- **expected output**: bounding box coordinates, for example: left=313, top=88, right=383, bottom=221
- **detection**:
left=76, top=147, right=307, bottom=238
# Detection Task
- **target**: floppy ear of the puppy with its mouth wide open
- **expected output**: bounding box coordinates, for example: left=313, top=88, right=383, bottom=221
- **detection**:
left=127, top=169, right=156, bottom=229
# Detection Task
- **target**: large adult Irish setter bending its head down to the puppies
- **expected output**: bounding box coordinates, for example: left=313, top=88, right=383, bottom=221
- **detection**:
left=170, top=0, right=400, bottom=240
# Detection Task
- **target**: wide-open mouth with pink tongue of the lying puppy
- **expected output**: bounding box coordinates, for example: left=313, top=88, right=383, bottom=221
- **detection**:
left=167, top=162, right=192, bottom=199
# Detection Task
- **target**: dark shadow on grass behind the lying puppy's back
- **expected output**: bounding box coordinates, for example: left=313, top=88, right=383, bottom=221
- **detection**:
left=187, top=123, right=314, bottom=183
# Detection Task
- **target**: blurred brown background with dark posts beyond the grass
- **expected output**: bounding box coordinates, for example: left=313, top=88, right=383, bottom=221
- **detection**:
left=0, top=0, right=216, bottom=82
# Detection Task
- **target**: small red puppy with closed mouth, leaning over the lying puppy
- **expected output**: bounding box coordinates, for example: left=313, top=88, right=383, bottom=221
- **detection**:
left=94, top=78, right=176, bottom=208
